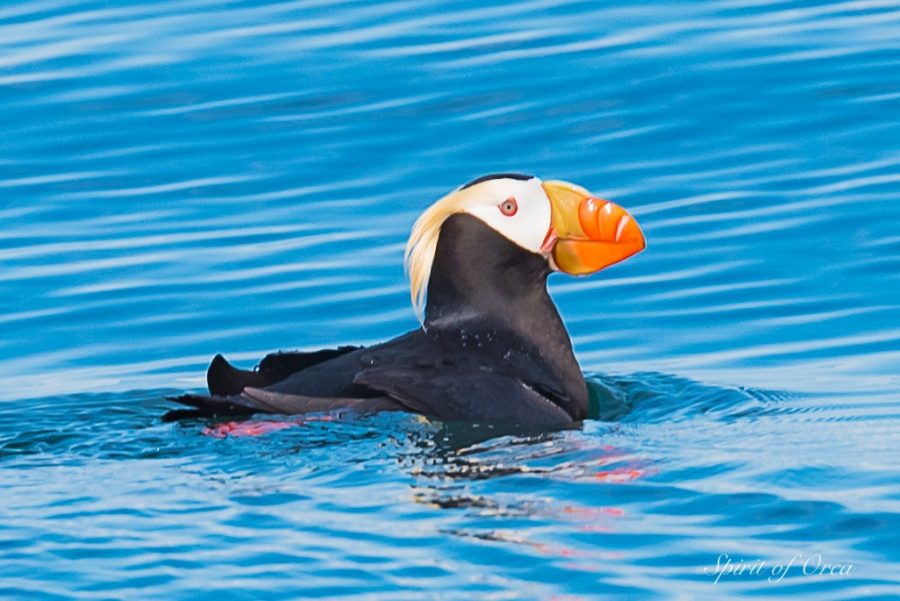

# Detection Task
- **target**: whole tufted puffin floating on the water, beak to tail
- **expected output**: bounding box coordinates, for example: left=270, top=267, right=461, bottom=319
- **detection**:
left=166, top=173, right=645, bottom=429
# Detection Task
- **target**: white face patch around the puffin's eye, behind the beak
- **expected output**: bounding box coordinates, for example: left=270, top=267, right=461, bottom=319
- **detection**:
left=463, top=177, right=551, bottom=254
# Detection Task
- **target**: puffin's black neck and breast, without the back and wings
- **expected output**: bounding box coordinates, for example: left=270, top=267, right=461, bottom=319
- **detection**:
left=425, top=214, right=587, bottom=419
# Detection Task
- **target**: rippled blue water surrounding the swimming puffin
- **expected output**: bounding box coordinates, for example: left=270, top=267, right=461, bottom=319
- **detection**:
left=0, top=0, right=900, bottom=601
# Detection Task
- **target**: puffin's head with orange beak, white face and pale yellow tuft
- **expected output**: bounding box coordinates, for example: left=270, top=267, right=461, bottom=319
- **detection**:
left=405, top=173, right=646, bottom=317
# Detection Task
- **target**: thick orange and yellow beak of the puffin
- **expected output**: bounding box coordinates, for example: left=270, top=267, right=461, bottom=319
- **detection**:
left=542, top=181, right=647, bottom=275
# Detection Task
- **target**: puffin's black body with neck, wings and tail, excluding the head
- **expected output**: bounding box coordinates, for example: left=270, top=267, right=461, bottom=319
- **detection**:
left=168, top=214, right=588, bottom=428
